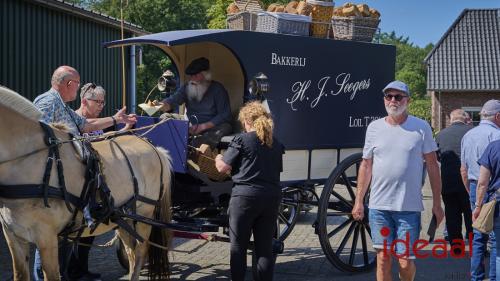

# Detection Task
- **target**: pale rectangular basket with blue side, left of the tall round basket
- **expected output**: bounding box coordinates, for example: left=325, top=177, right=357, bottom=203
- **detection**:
left=256, top=13, right=311, bottom=36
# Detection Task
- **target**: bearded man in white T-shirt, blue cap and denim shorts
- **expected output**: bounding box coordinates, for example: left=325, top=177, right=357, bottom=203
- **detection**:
left=352, top=81, right=444, bottom=281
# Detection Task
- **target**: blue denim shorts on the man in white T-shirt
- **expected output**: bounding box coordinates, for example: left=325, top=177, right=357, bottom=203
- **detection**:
left=368, top=209, right=421, bottom=259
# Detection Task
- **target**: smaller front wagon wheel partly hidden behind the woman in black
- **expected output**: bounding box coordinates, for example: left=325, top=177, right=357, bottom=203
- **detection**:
left=277, top=187, right=302, bottom=241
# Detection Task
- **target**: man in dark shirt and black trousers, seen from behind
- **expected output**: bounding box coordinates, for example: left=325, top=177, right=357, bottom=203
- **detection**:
left=436, top=109, right=472, bottom=255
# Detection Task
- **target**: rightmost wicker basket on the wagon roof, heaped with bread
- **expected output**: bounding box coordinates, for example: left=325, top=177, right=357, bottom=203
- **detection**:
left=332, top=17, right=380, bottom=42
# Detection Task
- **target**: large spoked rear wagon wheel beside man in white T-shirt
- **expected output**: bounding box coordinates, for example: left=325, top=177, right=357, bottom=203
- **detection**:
left=318, top=153, right=376, bottom=272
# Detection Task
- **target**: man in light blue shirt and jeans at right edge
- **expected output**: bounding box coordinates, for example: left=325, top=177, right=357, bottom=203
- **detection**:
left=460, top=100, right=500, bottom=281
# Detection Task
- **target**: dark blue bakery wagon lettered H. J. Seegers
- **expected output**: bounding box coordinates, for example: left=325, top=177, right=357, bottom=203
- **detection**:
left=105, top=30, right=396, bottom=272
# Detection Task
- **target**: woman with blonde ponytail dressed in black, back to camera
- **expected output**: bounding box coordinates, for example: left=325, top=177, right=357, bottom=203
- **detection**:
left=215, top=102, right=284, bottom=281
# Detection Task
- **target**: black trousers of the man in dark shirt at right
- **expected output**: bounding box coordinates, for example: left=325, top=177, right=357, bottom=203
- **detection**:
left=442, top=189, right=472, bottom=247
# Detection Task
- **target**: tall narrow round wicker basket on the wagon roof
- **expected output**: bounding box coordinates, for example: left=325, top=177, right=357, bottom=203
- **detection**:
left=307, top=0, right=334, bottom=38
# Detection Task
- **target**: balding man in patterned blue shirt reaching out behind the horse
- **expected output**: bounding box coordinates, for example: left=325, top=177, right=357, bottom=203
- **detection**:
left=34, top=66, right=136, bottom=280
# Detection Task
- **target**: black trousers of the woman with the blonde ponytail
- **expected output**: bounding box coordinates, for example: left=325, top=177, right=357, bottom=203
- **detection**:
left=228, top=191, right=281, bottom=281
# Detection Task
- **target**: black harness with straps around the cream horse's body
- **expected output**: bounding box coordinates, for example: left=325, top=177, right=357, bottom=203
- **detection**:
left=0, top=122, right=170, bottom=242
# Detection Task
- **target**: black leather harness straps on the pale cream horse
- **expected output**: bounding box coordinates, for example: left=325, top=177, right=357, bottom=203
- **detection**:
left=0, top=122, right=170, bottom=242
